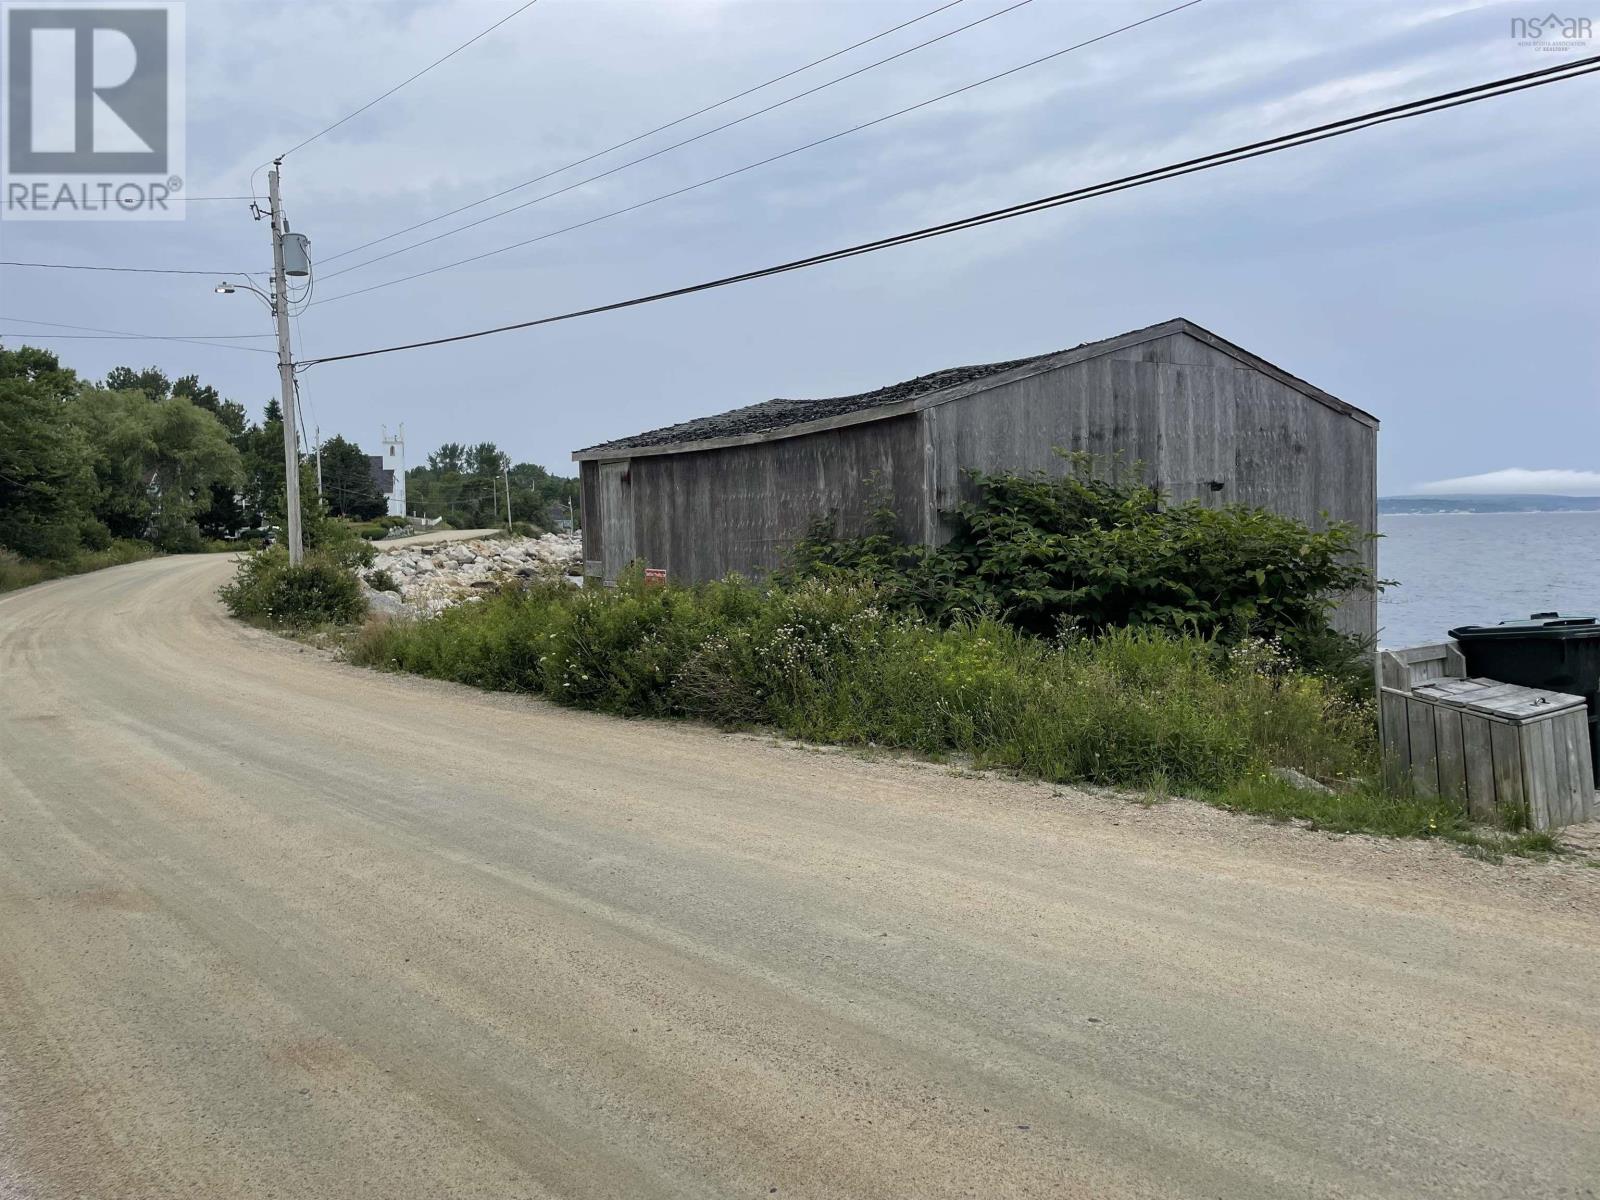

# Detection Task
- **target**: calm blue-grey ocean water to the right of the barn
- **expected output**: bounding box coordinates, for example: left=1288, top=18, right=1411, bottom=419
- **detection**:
left=1378, top=512, right=1600, bottom=646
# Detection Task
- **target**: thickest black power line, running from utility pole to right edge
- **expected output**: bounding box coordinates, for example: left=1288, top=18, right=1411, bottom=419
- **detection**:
left=306, top=54, right=1600, bottom=366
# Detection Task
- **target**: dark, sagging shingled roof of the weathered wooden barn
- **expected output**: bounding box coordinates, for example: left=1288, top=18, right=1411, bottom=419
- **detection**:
left=573, top=317, right=1376, bottom=459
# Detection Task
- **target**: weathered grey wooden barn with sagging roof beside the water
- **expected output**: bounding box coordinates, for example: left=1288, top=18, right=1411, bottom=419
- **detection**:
left=573, top=318, right=1378, bottom=635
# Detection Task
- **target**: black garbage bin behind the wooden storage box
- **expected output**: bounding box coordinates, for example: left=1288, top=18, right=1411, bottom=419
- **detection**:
left=1450, top=613, right=1600, bottom=784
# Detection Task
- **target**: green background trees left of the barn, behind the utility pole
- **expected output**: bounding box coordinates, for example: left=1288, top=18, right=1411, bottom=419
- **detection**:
left=0, top=346, right=578, bottom=579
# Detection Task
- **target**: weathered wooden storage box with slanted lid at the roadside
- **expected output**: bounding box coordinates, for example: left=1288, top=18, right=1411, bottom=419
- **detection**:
left=1379, top=678, right=1595, bottom=829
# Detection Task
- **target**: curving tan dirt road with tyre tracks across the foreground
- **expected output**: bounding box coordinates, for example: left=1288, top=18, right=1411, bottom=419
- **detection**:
left=0, top=557, right=1600, bottom=1200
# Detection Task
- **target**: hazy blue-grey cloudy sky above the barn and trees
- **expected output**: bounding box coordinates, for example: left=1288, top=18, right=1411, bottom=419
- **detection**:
left=0, top=0, right=1600, bottom=494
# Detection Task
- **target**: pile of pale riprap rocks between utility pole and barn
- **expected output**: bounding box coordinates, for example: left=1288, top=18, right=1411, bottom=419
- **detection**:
left=360, top=533, right=582, bottom=616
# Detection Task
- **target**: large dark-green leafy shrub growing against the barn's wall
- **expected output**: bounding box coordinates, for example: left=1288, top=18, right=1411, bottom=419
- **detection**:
left=784, top=454, right=1376, bottom=685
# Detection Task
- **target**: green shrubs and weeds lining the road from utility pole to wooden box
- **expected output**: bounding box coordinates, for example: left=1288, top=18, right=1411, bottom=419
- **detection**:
left=224, top=451, right=1554, bottom=858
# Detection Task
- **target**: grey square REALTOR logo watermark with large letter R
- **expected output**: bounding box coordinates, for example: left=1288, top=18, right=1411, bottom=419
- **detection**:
left=0, top=0, right=184, bottom=221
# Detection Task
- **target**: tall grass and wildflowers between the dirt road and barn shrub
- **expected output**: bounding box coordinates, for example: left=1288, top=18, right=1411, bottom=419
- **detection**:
left=349, top=581, right=1374, bottom=794
